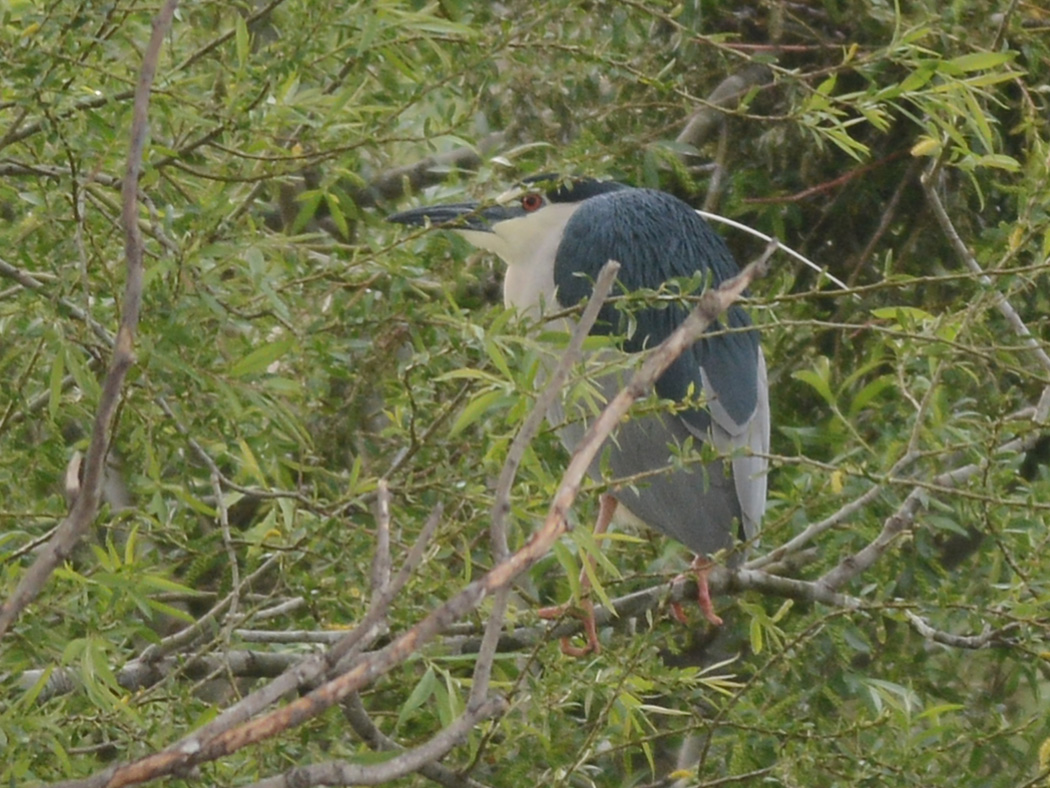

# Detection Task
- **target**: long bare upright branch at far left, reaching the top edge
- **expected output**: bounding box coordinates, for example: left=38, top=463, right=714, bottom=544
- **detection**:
left=0, top=0, right=179, bottom=638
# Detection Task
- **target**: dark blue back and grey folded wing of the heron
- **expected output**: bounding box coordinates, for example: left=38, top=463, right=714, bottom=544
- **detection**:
left=554, top=189, right=770, bottom=553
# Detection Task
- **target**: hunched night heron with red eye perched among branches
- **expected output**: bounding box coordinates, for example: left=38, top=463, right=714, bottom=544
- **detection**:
left=387, top=173, right=770, bottom=656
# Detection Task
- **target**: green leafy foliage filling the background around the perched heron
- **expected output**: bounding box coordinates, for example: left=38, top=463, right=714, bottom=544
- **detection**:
left=0, top=0, right=1050, bottom=787
